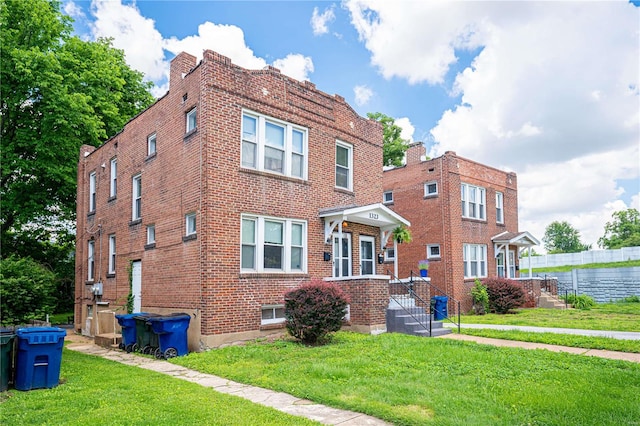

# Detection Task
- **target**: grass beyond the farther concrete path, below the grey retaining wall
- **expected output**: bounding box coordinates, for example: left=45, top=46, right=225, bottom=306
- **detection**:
left=461, top=303, right=640, bottom=331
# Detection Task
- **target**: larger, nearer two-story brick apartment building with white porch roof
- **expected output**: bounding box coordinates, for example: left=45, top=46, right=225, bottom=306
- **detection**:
left=75, top=51, right=409, bottom=351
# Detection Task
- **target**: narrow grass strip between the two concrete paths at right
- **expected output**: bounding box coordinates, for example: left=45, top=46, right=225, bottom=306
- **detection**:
left=460, top=328, right=640, bottom=353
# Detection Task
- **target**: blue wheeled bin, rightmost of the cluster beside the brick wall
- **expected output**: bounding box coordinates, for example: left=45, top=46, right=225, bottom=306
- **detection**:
left=149, top=313, right=191, bottom=359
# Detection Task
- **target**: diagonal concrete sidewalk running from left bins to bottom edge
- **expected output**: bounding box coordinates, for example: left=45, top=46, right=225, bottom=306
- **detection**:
left=65, top=332, right=390, bottom=426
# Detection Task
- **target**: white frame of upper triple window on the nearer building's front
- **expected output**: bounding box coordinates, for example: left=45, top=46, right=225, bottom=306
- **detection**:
left=240, top=110, right=309, bottom=180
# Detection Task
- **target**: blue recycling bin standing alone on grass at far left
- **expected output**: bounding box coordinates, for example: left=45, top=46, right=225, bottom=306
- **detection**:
left=14, top=327, right=67, bottom=391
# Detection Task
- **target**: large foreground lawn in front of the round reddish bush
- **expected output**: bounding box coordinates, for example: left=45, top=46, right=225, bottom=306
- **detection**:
left=171, top=332, right=640, bottom=425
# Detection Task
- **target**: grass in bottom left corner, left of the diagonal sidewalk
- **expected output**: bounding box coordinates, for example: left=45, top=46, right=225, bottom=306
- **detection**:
left=0, top=349, right=317, bottom=426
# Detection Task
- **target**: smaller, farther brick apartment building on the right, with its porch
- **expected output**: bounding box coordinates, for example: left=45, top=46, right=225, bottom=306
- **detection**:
left=383, top=142, right=539, bottom=312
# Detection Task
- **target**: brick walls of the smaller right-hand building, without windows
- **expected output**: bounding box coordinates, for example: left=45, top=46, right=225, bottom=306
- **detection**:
left=384, top=143, right=518, bottom=312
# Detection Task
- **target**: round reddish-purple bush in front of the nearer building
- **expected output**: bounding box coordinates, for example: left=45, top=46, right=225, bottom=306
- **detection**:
left=284, top=280, right=349, bottom=344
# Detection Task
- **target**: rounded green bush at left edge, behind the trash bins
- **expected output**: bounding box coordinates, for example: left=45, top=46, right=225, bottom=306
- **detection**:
left=0, top=256, right=56, bottom=326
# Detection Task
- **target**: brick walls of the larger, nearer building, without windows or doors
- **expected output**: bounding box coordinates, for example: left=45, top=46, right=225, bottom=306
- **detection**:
left=75, top=51, right=404, bottom=350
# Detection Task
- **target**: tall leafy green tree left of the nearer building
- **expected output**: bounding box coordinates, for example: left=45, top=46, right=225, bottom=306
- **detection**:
left=0, top=0, right=153, bottom=242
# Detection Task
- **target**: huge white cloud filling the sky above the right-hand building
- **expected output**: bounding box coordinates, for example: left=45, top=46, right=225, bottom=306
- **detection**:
left=346, top=0, right=640, bottom=247
